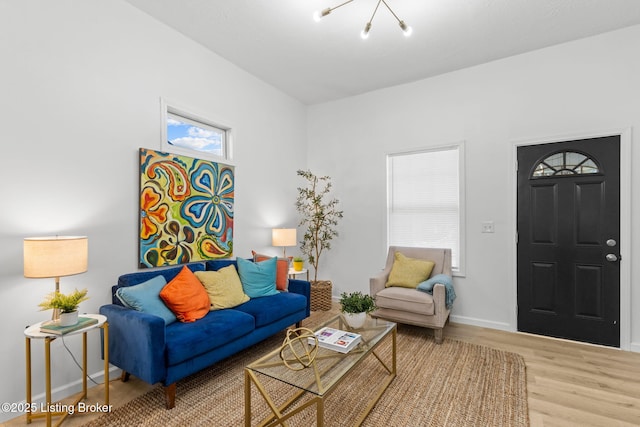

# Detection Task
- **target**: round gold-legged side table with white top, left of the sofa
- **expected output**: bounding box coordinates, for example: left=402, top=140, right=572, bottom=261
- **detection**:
left=24, top=314, right=109, bottom=427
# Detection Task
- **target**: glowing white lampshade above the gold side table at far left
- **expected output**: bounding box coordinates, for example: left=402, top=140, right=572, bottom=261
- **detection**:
left=24, top=236, right=89, bottom=278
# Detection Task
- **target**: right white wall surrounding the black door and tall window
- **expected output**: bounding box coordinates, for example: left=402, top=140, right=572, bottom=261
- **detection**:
left=308, top=26, right=640, bottom=351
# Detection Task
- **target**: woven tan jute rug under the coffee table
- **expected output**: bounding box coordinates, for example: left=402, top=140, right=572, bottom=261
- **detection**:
left=86, top=318, right=529, bottom=427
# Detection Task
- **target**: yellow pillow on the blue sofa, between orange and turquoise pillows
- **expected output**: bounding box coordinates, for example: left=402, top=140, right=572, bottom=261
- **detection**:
left=195, top=265, right=249, bottom=310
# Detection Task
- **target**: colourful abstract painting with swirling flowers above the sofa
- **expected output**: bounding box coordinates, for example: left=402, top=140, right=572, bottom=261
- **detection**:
left=140, top=148, right=234, bottom=267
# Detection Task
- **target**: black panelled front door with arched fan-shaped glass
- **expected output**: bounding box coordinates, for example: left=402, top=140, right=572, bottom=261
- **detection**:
left=517, top=136, right=620, bottom=347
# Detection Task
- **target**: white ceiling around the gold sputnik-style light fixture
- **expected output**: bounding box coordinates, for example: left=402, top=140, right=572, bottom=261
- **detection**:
left=125, top=0, right=640, bottom=105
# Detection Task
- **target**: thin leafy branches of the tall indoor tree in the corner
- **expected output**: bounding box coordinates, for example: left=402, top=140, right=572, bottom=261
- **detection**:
left=296, top=170, right=342, bottom=282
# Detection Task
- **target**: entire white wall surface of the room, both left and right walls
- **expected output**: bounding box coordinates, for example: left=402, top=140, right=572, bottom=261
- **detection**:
left=0, top=0, right=640, bottom=421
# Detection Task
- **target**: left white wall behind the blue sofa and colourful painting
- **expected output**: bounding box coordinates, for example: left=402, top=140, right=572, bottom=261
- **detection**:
left=0, top=0, right=306, bottom=421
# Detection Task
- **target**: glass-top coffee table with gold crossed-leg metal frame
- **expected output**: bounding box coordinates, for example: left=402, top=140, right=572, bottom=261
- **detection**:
left=244, top=315, right=397, bottom=427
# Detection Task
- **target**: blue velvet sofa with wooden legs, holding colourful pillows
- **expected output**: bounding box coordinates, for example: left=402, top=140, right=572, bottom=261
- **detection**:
left=100, top=260, right=311, bottom=409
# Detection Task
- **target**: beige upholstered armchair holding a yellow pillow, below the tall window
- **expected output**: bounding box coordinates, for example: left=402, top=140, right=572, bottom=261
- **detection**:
left=369, top=246, right=451, bottom=344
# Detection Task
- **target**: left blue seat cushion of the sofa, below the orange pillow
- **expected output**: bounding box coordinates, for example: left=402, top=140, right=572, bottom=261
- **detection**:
left=165, top=309, right=255, bottom=365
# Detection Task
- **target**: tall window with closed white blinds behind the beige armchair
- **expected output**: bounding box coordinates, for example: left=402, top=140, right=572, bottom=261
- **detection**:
left=387, top=144, right=464, bottom=274
